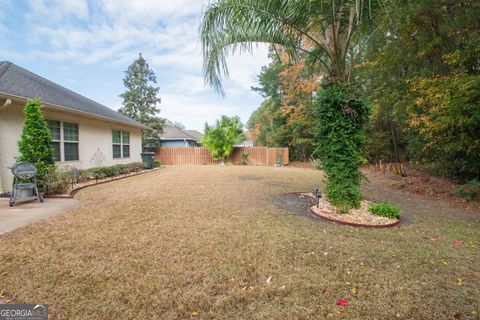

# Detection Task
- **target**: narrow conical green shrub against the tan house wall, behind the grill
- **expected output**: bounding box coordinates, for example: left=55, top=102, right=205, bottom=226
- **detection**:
left=17, top=99, right=55, bottom=187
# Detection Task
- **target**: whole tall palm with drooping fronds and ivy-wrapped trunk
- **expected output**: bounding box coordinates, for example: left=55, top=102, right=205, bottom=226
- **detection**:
left=200, top=0, right=392, bottom=209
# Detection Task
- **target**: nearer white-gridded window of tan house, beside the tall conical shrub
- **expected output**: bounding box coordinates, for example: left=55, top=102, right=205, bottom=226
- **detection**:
left=47, top=120, right=79, bottom=161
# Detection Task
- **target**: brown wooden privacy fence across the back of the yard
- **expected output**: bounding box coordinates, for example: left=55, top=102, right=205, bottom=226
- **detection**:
left=154, top=147, right=288, bottom=166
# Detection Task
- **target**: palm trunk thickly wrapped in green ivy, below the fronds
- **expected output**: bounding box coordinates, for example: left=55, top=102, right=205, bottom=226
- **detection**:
left=314, top=84, right=370, bottom=212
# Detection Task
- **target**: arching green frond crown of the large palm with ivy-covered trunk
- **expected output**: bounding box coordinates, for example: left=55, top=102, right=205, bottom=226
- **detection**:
left=200, top=0, right=393, bottom=94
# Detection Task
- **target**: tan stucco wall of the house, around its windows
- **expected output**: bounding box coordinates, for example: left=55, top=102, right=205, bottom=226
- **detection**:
left=0, top=102, right=142, bottom=192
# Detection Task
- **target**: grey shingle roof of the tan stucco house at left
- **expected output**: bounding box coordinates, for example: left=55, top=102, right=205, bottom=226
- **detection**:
left=0, top=61, right=148, bottom=129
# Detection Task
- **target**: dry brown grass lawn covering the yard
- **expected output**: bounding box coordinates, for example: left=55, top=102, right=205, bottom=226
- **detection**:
left=0, top=166, right=480, bottom=319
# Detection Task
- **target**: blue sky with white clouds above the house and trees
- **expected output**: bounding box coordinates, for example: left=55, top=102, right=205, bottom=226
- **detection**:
left=0, top=0, right=268, bottom=131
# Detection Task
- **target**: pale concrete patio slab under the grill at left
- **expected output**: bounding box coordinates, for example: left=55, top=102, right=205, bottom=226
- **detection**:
left=0, top=198, right=80, bottom=234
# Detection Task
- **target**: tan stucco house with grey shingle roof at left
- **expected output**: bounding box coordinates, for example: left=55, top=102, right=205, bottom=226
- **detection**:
left=0, top=61, right=148, bottom=193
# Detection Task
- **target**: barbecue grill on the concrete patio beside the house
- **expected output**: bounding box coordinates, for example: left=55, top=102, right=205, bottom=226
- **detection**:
left=9, top=161, right=43, bottom=207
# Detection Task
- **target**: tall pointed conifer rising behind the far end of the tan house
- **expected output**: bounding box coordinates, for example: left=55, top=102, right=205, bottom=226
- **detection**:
left=118, top=53, right=164, bottom=146
